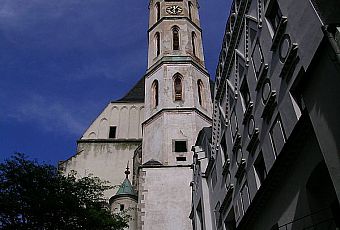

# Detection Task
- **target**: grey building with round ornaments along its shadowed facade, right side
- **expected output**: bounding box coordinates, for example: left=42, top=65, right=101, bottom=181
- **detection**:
left=191, top=0, right=340, bottom=230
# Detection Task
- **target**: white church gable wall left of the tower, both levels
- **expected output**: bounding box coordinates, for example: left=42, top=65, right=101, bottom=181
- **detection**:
left=59, top=103, right=144, bottom=198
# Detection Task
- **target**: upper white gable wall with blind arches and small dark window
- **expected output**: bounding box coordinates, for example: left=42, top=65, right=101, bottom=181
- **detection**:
left=81, top=102, right=144, bottom=140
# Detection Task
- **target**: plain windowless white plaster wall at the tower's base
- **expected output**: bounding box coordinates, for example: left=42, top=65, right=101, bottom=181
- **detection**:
left=139, top=167, right=192, bottom=230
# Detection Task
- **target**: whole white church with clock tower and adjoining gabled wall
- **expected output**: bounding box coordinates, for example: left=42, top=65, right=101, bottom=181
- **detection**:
left=59, top=0, right=212, bottom=230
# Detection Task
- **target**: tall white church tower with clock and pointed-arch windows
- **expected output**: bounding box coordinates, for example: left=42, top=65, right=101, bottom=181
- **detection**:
left=138, top=0, right=212, bottom=230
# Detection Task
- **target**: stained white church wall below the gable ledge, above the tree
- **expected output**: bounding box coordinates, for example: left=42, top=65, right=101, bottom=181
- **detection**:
left=60, top=142, right=140, bottom=199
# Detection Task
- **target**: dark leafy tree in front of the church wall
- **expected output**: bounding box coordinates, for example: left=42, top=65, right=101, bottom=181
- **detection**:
left=0, top=154, right=129, bottom=230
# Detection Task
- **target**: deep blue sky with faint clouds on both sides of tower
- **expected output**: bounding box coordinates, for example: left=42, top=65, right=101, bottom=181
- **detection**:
left=0, top=0, right=230, bottom=165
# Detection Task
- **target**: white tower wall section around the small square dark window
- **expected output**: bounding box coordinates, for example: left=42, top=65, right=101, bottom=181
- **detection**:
left=143, top=110, right=211, bottom=165
